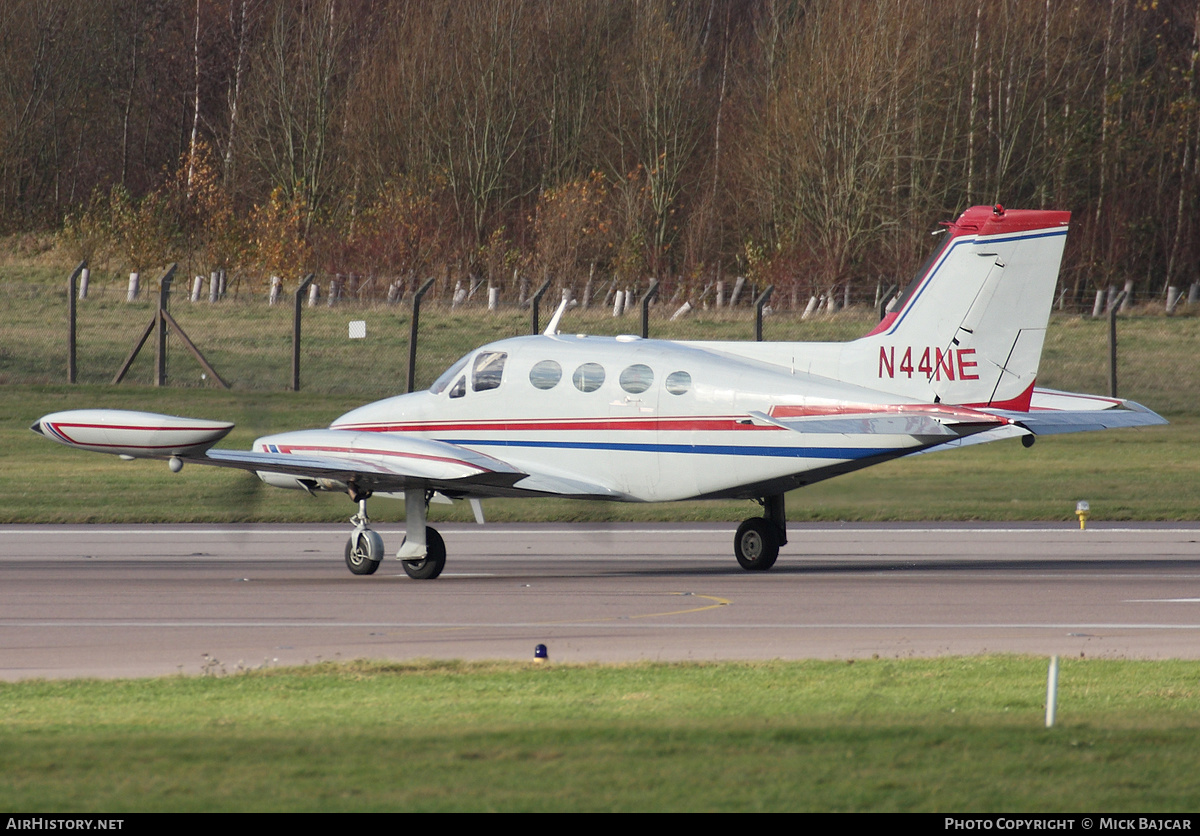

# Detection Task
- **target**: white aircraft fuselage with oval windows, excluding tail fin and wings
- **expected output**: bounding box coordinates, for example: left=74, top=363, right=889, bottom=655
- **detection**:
left=330, top=335, right=923, bottom=501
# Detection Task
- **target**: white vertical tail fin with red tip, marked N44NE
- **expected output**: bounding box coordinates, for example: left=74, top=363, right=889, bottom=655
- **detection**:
left=859, top=206, right=1070, bottom=410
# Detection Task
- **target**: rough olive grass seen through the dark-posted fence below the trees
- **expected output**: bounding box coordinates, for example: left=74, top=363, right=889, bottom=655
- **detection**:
left=0, top=271, right=1200, bottom=413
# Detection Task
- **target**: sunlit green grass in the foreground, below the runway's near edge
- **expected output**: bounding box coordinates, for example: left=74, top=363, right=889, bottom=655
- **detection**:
left=0, top=656, right=1200, bottom=813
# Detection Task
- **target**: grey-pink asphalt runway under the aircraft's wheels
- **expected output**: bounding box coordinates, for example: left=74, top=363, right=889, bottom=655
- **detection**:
left=0, top=523, right=1200, bottom=680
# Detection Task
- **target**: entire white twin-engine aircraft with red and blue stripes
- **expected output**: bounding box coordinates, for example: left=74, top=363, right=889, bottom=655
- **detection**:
left=32, top=206, right=1165, bottom=579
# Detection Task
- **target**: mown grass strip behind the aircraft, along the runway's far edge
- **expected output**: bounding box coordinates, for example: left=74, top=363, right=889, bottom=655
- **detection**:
left=0, top=386, right=1200, bottom=523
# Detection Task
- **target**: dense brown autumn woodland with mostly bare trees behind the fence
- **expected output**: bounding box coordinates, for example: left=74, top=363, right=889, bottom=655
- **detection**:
left=7, top=0, right=1200, bottom=303
